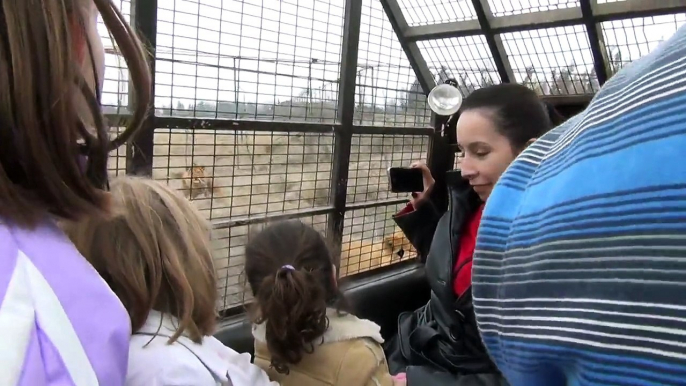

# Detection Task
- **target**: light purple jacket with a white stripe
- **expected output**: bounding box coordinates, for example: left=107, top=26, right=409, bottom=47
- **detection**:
left=0, top=219, right=131, bottom=386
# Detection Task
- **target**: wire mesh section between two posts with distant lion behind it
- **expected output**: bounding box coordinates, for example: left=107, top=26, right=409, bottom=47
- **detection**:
left=153, top=129, right=333, bottom=220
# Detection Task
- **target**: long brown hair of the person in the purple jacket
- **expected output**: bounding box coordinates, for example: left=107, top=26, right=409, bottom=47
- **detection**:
left=0, top=0, right=151, bottom=227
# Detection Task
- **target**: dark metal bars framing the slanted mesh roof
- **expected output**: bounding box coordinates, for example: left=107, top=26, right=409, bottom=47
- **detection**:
left=379, top=0, right=686, bottom=103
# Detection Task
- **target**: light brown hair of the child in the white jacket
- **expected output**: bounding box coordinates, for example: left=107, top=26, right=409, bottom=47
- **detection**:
left=64, top=177, right=217, bottom=342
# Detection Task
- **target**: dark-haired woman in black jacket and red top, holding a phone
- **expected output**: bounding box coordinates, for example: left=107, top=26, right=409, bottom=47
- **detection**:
left=386, top=84, right=561, bottom=386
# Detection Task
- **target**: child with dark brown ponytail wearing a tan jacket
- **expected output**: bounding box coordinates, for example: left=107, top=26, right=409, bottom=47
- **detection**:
left=245, top=221, right=405, bottom=386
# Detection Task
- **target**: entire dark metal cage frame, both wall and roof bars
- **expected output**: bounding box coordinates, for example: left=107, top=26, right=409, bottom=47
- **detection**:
left=115, top=0, right=686, bottom=314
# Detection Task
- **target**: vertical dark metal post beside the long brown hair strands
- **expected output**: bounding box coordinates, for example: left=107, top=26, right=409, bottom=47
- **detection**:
left=126, top=0, right=157, bottom=176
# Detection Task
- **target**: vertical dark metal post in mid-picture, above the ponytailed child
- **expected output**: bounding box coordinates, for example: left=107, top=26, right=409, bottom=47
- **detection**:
left=328, top=0, right=362, bottom=267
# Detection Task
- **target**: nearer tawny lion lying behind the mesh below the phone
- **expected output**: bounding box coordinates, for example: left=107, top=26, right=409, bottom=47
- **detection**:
left=340, top=228, right=417, bottom=277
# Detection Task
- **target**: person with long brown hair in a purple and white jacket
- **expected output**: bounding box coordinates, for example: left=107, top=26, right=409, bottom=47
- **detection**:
left=0, top=0, right=151, bottom=386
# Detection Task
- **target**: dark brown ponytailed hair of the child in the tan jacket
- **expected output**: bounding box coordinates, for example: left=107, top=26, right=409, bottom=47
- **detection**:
left=245, top=221, right=345, bottom=373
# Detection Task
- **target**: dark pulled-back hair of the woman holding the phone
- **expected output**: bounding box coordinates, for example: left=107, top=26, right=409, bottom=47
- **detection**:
left=460, top=83, right=563, bottom=151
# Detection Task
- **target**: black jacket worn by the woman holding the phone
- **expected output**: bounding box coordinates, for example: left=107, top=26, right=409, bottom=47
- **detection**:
left=386, top=171, right=506, bottom=386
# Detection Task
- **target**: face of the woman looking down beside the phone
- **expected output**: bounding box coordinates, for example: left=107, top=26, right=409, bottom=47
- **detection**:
left=457, top=110, right=517, bottom=201
